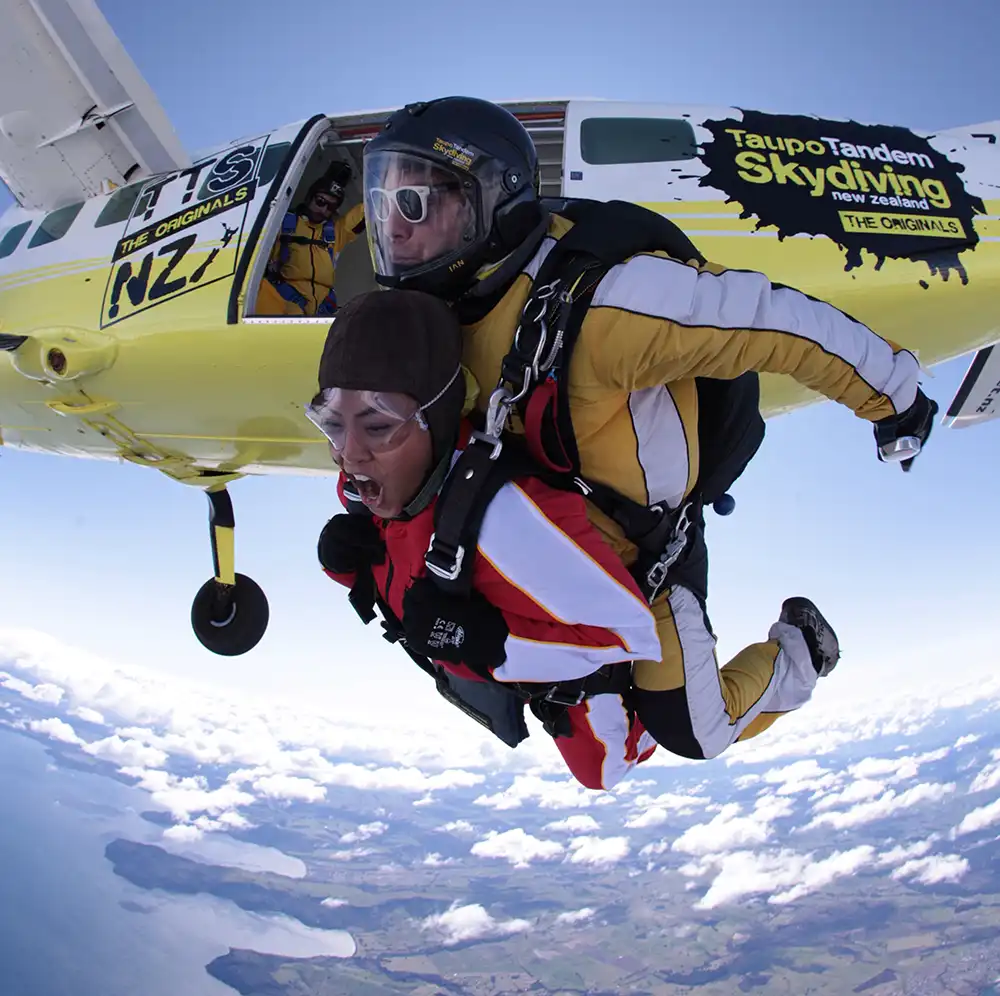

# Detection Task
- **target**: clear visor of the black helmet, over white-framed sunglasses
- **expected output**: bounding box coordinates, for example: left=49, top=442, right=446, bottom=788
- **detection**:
left=364, top=151, right=482, bottom=276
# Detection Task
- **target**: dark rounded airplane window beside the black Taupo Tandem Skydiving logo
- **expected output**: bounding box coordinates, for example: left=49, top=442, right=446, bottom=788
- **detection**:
left=580, top=118, right=698, bottom=166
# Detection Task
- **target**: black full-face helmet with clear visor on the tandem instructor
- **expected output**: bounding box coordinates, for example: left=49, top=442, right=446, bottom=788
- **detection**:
left=364, top=97, right=546, bottom=300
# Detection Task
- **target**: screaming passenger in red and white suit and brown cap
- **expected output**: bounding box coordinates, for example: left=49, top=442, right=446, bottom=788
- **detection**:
left=307, top=290, right=836, bottom=789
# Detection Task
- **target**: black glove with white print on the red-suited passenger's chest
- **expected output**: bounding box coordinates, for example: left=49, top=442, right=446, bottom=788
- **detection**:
left=403, top=577, right=510, bottom=676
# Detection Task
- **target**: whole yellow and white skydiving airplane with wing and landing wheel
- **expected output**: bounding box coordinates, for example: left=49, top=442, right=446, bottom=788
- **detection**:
left=0, top=0, right=1000, bottom=655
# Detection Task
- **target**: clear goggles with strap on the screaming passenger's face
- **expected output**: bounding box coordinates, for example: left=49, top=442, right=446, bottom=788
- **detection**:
left=305, top=364, right=462, bottom=454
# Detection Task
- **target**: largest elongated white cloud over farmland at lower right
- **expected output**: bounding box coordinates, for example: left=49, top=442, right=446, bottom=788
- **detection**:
left=682, top=844, right=875, bottom=909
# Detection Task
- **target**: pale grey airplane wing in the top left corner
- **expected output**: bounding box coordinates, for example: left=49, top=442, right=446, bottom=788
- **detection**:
left=0, top=0, right=190, bottom=210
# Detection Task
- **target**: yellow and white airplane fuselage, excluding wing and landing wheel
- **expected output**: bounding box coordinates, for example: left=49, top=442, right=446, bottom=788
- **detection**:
left=0, top=101, right=1000, bottom=478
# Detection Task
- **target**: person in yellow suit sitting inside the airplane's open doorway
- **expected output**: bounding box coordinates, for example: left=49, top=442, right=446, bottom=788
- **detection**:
left=257, top=162, right=365, bottom=317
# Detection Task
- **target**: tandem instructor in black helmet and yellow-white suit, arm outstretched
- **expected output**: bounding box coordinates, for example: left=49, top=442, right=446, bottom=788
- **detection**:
left=363, top=97, right=937, bottom=759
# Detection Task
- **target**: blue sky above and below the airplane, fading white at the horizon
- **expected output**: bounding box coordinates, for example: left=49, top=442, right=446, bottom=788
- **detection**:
left=0, top=0, right=1000, bottom=728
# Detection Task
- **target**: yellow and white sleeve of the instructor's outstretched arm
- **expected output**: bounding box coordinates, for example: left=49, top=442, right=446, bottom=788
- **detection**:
left=578, top=253, right=920, bottom=421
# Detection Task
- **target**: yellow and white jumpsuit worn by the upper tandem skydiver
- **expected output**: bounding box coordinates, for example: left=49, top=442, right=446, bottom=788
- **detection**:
left=465, top=216, right=920, bottom=758
